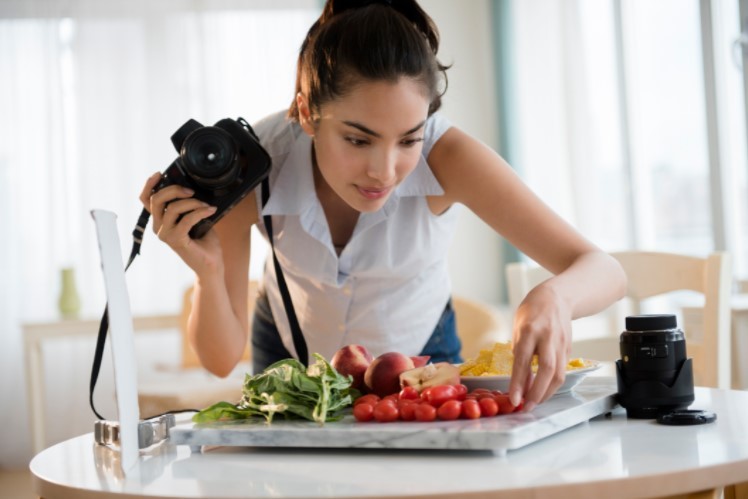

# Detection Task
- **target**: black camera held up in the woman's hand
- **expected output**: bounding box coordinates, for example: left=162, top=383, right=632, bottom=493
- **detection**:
left=156, top=118, right=271, bottom=239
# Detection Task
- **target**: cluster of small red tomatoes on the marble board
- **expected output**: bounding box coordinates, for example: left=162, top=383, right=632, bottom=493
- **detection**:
left=353, top=385, right=522, bottom=423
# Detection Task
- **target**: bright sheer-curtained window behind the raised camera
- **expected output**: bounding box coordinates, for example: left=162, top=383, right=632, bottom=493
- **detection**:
left=0, top=0, right=319, bottom=318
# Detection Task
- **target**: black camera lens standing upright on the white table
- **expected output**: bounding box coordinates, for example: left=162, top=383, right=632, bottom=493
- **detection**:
left=616, top=315, right=694, bottom=419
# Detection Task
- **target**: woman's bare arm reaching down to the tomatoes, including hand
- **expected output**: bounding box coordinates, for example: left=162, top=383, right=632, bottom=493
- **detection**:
left=428, top=127, right=626, bottom=409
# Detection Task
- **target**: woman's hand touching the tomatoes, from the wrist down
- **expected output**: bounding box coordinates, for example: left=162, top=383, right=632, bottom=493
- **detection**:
left=509, top=283, right=572, bottom=411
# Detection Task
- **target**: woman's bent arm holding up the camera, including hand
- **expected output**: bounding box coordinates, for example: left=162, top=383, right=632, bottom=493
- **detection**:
left=140, top=174, right=257, bottom=376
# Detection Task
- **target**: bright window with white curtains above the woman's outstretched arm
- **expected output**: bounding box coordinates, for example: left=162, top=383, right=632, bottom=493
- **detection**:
left=512, top=0, right=748, bottom=278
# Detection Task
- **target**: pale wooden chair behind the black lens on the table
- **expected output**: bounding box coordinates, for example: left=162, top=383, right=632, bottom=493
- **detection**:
left=506, top=251, right=732, bottom=388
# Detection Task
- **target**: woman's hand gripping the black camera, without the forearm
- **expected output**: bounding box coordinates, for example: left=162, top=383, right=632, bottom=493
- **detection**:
left=140, top=172, right=223, bottom=275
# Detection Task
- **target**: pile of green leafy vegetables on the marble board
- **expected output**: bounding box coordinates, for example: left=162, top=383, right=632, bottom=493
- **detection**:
left=192, top=353, right=359, bottom=424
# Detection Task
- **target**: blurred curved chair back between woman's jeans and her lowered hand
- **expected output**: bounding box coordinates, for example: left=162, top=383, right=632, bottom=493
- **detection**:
left=452, top=296, right=511, bottom=359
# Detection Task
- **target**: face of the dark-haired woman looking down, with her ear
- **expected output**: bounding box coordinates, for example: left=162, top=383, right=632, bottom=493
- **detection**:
left=299, top=78, right=429, bottom=212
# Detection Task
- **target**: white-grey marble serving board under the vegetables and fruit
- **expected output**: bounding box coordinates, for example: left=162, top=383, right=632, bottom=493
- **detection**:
left=169, top=377, right=617, bottom=452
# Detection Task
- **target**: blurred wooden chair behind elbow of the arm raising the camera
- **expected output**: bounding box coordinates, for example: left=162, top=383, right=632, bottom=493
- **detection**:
left=138, top=281, right=257, bottom=417
